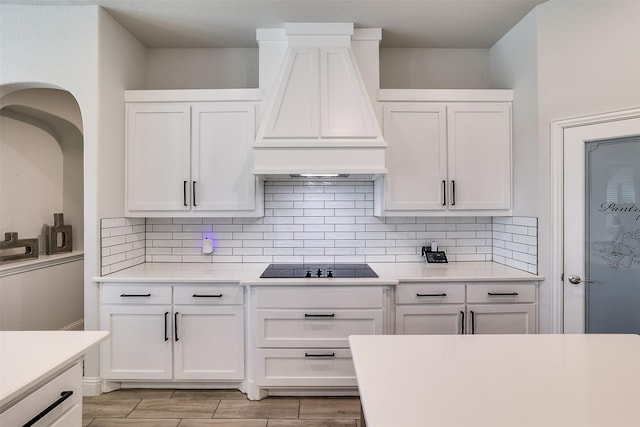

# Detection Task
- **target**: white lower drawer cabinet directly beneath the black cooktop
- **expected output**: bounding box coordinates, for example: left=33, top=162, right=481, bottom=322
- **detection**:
left=252, top=285, right=384, bottom=388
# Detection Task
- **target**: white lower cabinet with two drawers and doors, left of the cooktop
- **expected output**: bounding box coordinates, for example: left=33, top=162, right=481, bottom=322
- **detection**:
left=101, top=284, right=244, bottom=381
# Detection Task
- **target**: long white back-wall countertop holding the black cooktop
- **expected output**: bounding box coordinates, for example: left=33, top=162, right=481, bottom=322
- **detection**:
left=94, top=262, right=542, bottom=285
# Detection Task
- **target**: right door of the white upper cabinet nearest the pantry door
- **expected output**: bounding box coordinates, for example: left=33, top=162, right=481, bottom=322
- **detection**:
left=447, top=102, right=511, bottom=210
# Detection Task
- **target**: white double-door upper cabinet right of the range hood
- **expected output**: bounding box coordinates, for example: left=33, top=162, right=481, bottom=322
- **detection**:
left=376, top=90, right=512, bottom=216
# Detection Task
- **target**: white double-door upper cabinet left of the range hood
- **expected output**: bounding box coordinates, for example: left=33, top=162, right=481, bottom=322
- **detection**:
left=126, top=91, right=263, bottom=217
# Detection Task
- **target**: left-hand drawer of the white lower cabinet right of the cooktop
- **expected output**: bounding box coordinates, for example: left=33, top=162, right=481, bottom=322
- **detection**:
left=396, top=283, right=464, bottom=304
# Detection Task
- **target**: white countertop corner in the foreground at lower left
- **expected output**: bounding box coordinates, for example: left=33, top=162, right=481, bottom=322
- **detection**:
left=0, top=331, right=109, bottom=410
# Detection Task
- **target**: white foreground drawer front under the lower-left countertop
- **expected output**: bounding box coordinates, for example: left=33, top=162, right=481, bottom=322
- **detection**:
left=0, top=363, right=82, bottom=426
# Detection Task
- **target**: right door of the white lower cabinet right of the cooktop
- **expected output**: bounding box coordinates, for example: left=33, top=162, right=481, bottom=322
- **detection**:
left=467, top=304, right=536, bottom=334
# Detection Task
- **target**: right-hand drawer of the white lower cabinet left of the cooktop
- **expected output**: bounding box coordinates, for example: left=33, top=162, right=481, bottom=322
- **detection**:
left=173, top=285, right=244, bottom=305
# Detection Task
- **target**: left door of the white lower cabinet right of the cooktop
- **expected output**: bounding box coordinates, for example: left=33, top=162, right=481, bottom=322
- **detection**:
left=396, top=304, right=465, bottom=335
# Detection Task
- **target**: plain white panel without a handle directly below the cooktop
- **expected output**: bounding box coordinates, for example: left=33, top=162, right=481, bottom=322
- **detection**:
left=254, top=285, right=384, bottom=308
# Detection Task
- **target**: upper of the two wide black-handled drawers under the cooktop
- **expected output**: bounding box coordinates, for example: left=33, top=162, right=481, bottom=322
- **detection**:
left=255, top=309, right=383, bottom=348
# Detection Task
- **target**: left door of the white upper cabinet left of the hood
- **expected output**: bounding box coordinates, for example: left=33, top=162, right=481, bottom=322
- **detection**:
left=126, top=103, right=191, bottom=215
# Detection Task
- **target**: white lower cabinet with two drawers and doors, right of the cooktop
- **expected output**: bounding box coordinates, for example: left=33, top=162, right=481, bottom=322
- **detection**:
left=396, top=282, right=537, bottom=335
